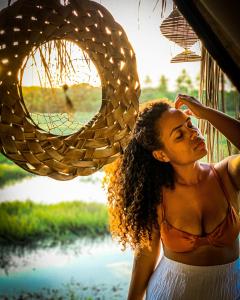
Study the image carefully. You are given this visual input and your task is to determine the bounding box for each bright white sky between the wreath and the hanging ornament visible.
[0,0,200,90]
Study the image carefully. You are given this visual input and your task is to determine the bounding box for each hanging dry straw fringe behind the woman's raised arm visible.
[199,47,240,162]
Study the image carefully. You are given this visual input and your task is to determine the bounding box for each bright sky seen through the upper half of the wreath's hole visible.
[19,41,101,88]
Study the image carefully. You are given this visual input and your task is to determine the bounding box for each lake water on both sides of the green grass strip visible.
[0,171,135,300]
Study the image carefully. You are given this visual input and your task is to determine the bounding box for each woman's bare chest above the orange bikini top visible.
[160,177,237,235]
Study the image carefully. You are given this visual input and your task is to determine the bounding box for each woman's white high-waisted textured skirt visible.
[145,256,240,300]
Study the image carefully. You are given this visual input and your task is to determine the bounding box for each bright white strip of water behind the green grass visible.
[0,171,107,204]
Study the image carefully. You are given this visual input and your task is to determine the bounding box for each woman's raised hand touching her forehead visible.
[175,94,207,119]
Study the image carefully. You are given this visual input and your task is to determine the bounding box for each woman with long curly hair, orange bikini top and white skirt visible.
[108,95,240,300]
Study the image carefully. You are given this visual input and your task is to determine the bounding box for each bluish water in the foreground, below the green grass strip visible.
[0,237,133,299]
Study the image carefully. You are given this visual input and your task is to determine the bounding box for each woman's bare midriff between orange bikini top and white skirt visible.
[163,239,239,266]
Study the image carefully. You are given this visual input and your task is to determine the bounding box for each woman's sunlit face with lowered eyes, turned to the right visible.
[156,108,207,165]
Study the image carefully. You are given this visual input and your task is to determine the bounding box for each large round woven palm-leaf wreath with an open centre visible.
[0,0,140,180]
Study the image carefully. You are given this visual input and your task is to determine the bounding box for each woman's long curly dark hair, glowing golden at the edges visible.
[106,99,174,253]
